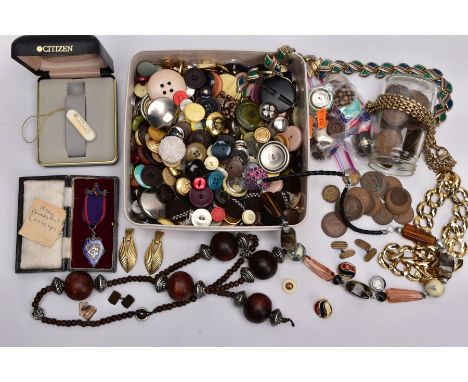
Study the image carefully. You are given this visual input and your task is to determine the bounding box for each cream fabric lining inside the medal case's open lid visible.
[20,180,70,269]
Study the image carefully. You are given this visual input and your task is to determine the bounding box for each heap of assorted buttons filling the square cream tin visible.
[129,55,303,227]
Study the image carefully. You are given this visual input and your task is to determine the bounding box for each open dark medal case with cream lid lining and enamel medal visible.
[15,176,119,273]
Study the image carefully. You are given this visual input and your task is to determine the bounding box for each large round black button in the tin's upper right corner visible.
[260,76,296,113]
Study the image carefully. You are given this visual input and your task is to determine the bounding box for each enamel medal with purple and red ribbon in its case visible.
[83,183,107,268]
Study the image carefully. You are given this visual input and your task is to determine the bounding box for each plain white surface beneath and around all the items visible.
[0,36,468,346]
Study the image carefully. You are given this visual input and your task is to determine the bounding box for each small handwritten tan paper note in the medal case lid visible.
[19,199,66,247]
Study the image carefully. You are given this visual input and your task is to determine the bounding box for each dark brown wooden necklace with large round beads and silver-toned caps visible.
[32,232,294,327]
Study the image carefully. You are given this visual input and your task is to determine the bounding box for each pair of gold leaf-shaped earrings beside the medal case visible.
[119,228,164,275]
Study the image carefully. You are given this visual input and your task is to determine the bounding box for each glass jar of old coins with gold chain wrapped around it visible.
[369,75,437,175]
